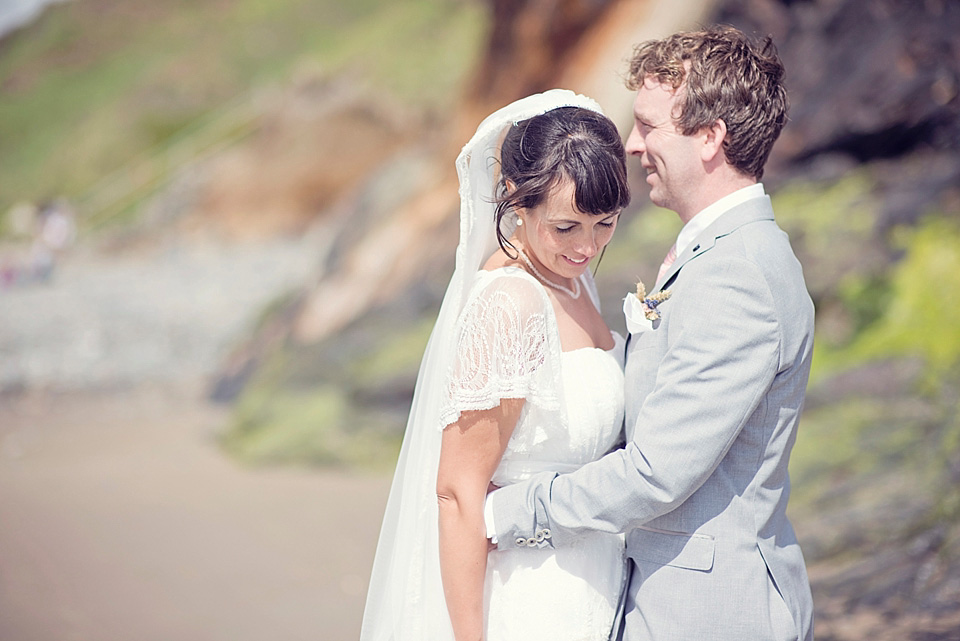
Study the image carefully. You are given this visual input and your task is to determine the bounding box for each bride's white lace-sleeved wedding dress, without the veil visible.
[441,267,625,641]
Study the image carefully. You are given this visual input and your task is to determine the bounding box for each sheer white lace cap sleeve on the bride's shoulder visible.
[440,268,560,428]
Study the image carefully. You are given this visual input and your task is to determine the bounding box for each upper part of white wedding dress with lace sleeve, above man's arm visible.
[440,267,623,485]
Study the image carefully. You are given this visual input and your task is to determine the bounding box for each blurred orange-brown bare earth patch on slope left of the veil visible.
[182,73,413,239]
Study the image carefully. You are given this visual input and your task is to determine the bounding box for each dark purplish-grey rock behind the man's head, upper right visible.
[715,0,960,229]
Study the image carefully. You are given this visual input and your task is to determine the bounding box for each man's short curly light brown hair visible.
[626,26,789,180]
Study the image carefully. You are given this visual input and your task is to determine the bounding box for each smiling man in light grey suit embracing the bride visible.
[487,27,813,641]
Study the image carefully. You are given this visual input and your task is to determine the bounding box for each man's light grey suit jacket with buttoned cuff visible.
[492,197,813,641]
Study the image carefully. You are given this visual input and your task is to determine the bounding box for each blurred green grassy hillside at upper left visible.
[0,0,485,229]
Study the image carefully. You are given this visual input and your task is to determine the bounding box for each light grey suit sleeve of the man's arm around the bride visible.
[493,252,781,548]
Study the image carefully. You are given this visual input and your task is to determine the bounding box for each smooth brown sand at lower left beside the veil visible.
[0,389,389,641]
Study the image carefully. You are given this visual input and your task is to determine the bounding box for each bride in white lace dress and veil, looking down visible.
[361,89,630,641]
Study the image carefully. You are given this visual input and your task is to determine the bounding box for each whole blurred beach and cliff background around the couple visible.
[0,0,960,641]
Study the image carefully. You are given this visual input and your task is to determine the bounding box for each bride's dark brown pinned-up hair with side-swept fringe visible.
[495,107,630,258]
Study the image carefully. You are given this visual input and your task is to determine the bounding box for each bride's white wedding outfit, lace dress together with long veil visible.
[360,89,625,641]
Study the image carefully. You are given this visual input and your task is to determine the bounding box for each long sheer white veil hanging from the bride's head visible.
[360,89,602,641]
